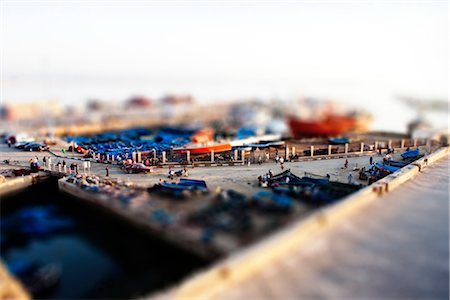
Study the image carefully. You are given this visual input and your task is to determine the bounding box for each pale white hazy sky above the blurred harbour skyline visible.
[1,1,449,130]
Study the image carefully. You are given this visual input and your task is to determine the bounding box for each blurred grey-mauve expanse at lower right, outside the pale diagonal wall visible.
[199,156,450,300]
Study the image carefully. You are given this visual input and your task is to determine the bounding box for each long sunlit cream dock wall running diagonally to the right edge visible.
[150,147,450,299]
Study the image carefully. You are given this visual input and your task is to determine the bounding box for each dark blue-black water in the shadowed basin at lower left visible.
[1,180,207,299]
